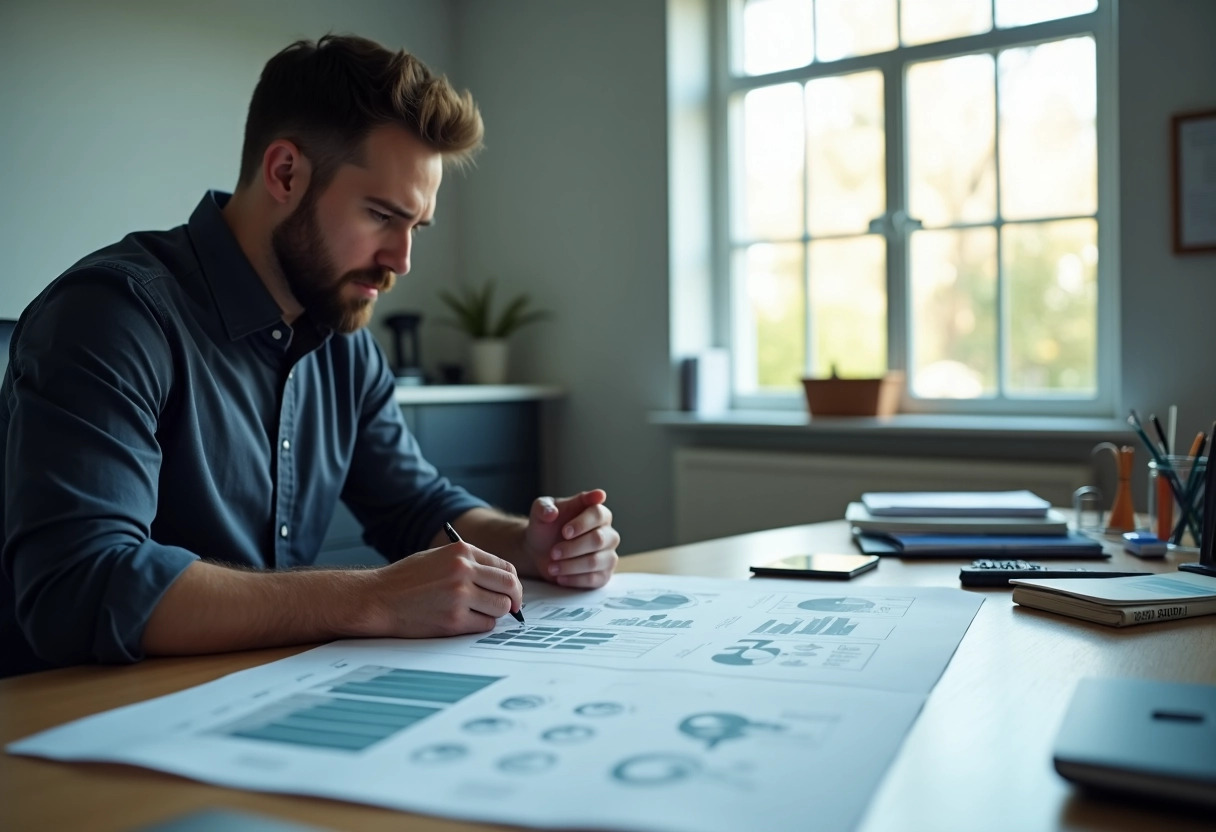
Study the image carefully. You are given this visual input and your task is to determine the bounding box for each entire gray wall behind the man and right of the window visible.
[0,0,1216,552]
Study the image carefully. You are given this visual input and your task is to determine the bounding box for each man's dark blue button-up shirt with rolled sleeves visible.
[0,192,485,675]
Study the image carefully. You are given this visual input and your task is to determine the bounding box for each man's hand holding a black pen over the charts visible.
[368,543,523,639]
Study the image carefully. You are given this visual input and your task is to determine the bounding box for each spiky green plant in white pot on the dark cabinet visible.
[439,280,550,384]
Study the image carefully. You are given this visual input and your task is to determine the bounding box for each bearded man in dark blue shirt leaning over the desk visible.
[0,36,620,674]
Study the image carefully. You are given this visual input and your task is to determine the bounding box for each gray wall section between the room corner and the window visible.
[456,0,671,551]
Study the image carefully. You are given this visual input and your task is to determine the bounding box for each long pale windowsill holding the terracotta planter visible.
[649,410,1136,442]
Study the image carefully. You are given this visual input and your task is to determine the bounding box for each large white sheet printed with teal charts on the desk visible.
[9,574,983,832]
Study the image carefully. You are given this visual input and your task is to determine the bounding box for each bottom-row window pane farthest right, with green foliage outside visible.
[1001,219,1098,395]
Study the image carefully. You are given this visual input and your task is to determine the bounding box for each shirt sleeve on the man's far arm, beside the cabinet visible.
[342,336,488,561]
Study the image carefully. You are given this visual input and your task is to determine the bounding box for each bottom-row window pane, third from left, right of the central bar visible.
[910,229,997,399]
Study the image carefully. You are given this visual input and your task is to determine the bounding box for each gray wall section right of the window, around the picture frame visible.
[1119,0,1216,450]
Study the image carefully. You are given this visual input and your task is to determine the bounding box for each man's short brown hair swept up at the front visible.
[240,35,484,187]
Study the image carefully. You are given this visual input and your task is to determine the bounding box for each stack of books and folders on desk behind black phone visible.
[845,491,1109,558]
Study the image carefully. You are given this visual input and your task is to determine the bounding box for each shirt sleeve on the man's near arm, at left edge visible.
[0,268,197,664]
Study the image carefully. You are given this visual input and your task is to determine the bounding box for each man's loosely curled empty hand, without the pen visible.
[524,488,620,589]
